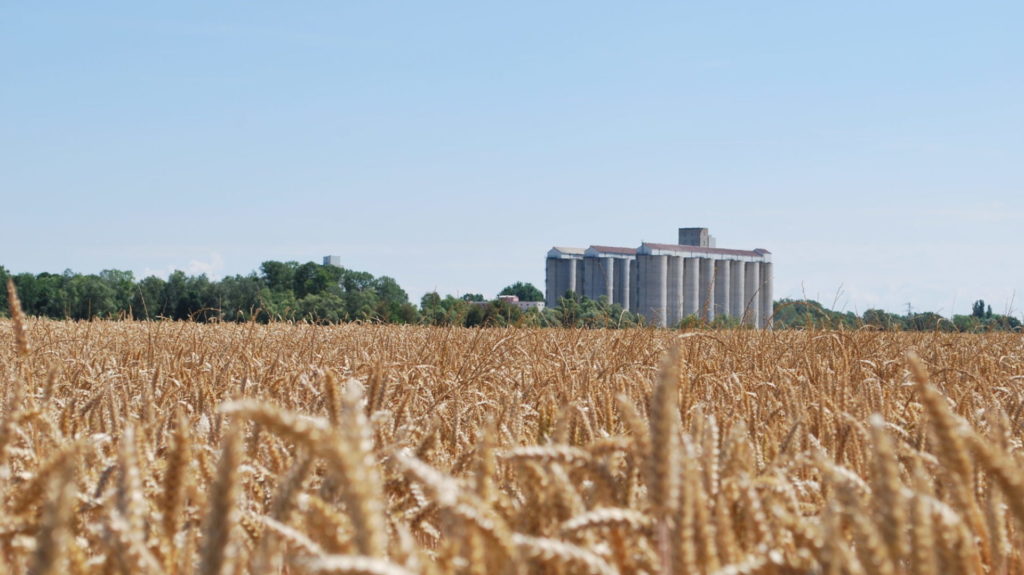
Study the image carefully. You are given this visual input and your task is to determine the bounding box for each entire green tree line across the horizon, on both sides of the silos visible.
[0,260,1021,333]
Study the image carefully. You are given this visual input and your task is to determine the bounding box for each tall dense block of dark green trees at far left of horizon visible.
[0,261,418,323]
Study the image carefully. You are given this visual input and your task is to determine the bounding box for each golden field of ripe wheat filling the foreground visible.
[0,313,1024,574]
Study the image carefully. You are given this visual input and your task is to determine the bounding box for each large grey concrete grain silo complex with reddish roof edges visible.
[545,228,773,327]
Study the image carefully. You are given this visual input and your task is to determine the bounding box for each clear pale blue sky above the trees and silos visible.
[0,0,1024,316]
